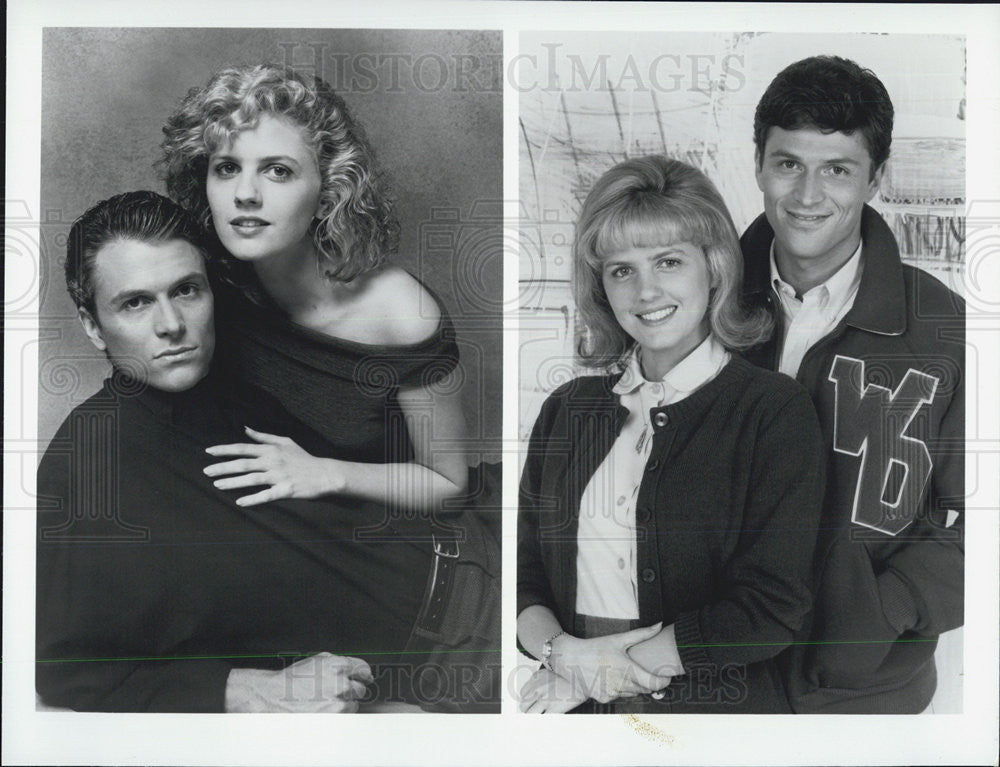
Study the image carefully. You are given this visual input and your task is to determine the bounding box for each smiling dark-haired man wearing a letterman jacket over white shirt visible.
[741,56,965,713]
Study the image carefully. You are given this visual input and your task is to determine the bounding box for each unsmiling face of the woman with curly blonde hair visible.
[205,115,322,261]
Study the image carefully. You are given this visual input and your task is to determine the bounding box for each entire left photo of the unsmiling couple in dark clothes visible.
[35,28,503,713]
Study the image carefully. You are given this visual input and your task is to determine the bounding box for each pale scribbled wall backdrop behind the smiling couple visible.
[513,32,966,713]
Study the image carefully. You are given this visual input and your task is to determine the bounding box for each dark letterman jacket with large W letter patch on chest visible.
[741,206,965,713]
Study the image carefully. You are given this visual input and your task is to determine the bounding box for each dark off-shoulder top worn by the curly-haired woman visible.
[213,285,458,463]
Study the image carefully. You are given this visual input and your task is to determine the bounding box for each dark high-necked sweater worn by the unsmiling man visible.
[36,375,431,712]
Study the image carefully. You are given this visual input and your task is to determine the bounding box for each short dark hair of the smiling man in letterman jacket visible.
[753,56,893,175]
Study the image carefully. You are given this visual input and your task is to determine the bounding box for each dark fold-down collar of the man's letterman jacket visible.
[740,205,906,336]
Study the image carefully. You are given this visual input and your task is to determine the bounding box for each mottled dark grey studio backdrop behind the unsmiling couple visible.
[38,28,503,462]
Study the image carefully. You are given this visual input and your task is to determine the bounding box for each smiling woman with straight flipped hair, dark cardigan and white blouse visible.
[517,156,822,713]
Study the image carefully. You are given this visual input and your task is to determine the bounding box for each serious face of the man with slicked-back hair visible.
[80,240,215,392]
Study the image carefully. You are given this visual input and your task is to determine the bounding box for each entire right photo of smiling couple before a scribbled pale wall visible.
[509,31,966,714]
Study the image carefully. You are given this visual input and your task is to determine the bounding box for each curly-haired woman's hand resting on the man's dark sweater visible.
[204,426,345,506]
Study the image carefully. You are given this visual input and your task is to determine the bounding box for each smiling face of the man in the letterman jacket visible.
[756,128,882,271]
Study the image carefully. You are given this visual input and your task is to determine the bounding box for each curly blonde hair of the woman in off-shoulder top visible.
[158,64,399,292]
